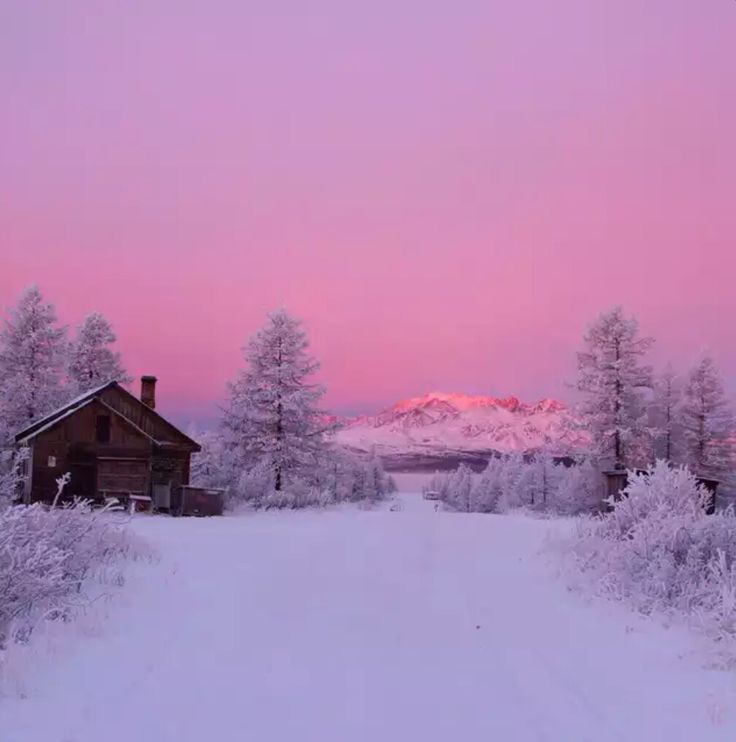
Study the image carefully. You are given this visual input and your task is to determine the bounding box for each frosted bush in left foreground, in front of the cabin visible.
[0,501,146,648]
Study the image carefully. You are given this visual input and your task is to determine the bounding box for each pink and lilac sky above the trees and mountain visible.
[0,0,736,419]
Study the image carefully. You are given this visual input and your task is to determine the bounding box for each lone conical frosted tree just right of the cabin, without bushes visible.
[222,309,325,492]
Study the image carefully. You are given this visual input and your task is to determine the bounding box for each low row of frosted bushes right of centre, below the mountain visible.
[426,455,602,515]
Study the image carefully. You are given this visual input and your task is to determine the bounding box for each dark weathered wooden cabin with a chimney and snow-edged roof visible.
[15,376,200,510]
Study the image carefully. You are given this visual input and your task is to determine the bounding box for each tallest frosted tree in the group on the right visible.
[577,307,654,467]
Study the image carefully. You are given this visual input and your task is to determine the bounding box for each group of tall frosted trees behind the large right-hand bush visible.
[577,307,734,479]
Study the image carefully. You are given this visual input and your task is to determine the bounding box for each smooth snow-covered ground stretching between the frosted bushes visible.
[0,495,736,742]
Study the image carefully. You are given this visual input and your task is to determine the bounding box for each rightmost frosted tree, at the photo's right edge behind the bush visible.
[681,356,734,477]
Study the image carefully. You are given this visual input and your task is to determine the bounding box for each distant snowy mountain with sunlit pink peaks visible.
[336,392,586,456]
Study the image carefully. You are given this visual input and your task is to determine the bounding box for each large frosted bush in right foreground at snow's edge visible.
[569,461,736,636]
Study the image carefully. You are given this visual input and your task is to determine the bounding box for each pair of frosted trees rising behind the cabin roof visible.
[0,286,129,444]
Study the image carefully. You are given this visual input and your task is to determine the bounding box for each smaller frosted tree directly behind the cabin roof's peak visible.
[68,312,132,394]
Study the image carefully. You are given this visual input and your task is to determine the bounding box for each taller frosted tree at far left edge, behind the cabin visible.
[0,286,67,439]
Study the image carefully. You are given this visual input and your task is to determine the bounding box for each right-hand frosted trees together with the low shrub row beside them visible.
[429,307,736,514]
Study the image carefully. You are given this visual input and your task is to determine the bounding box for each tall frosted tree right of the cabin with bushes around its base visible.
[192,309,393,507]
